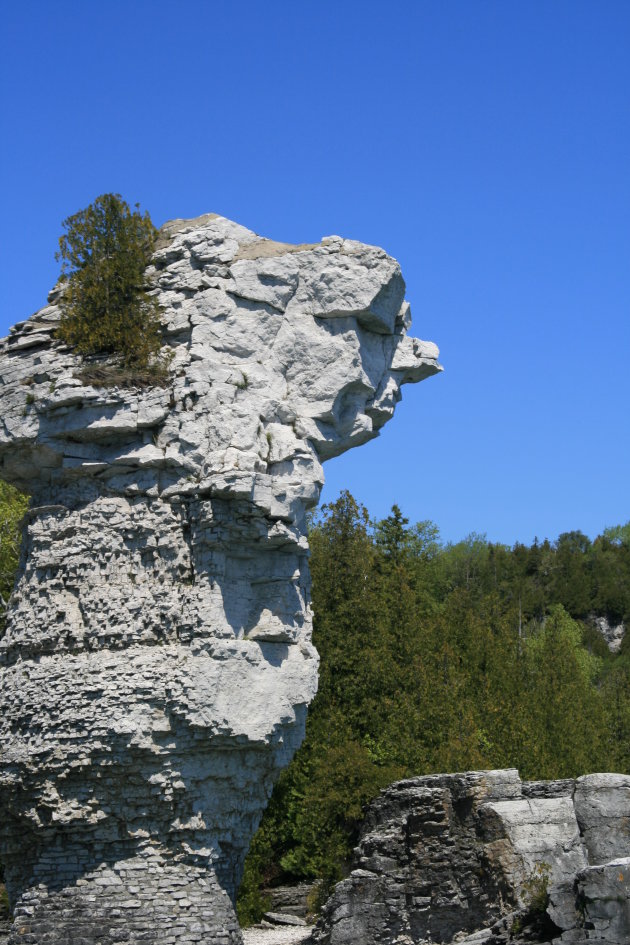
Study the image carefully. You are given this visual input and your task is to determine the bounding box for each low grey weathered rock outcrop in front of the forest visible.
[314,769,630,945]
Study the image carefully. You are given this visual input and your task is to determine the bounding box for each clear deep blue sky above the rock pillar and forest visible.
[0,0,630,544]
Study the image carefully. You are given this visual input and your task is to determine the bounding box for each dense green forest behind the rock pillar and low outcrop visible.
[240,492,630,921]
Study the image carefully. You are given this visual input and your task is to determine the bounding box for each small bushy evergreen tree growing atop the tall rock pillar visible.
[57,194,161,373]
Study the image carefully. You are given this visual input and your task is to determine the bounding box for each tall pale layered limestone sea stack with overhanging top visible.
[0,214,440,945]
